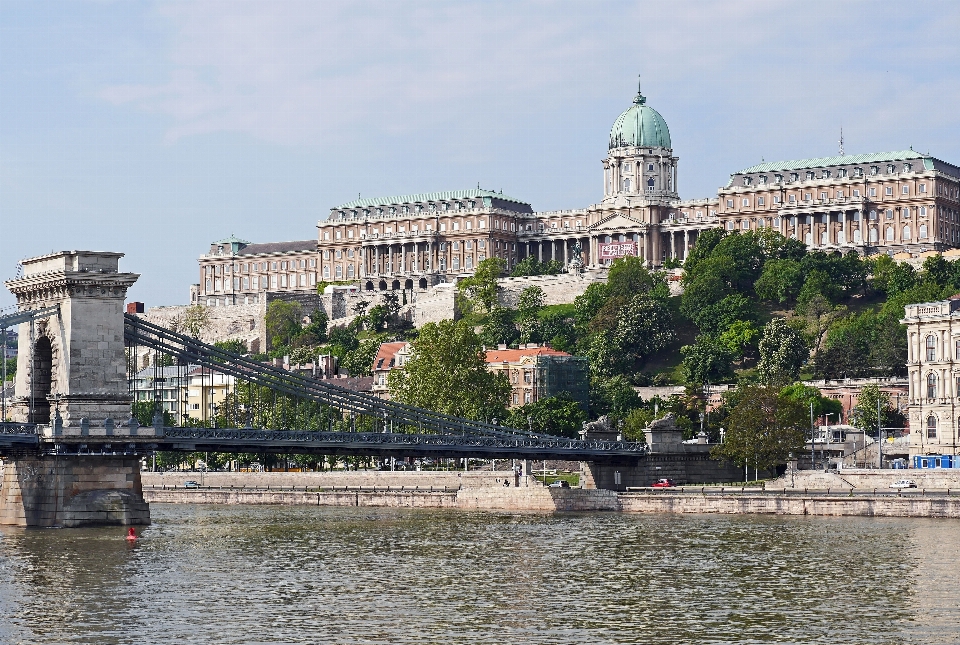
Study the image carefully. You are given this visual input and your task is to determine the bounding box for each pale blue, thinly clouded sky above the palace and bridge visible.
[0,0,960,308]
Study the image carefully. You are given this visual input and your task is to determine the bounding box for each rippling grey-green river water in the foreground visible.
[0,504,960,645]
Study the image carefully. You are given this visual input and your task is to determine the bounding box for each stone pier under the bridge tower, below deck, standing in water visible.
[0,455,150,527]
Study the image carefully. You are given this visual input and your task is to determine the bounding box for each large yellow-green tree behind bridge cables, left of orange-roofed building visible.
[388,320,510,419]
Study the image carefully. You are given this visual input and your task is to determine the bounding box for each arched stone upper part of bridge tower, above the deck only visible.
[6,251,140,428]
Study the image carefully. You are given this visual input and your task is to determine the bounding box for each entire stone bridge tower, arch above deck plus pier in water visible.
[0,251,150,526]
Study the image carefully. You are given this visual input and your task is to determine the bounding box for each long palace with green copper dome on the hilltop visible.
[191,83,960,305]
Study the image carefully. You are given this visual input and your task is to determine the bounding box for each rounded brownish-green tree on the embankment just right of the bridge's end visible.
[711,386,809,470]
